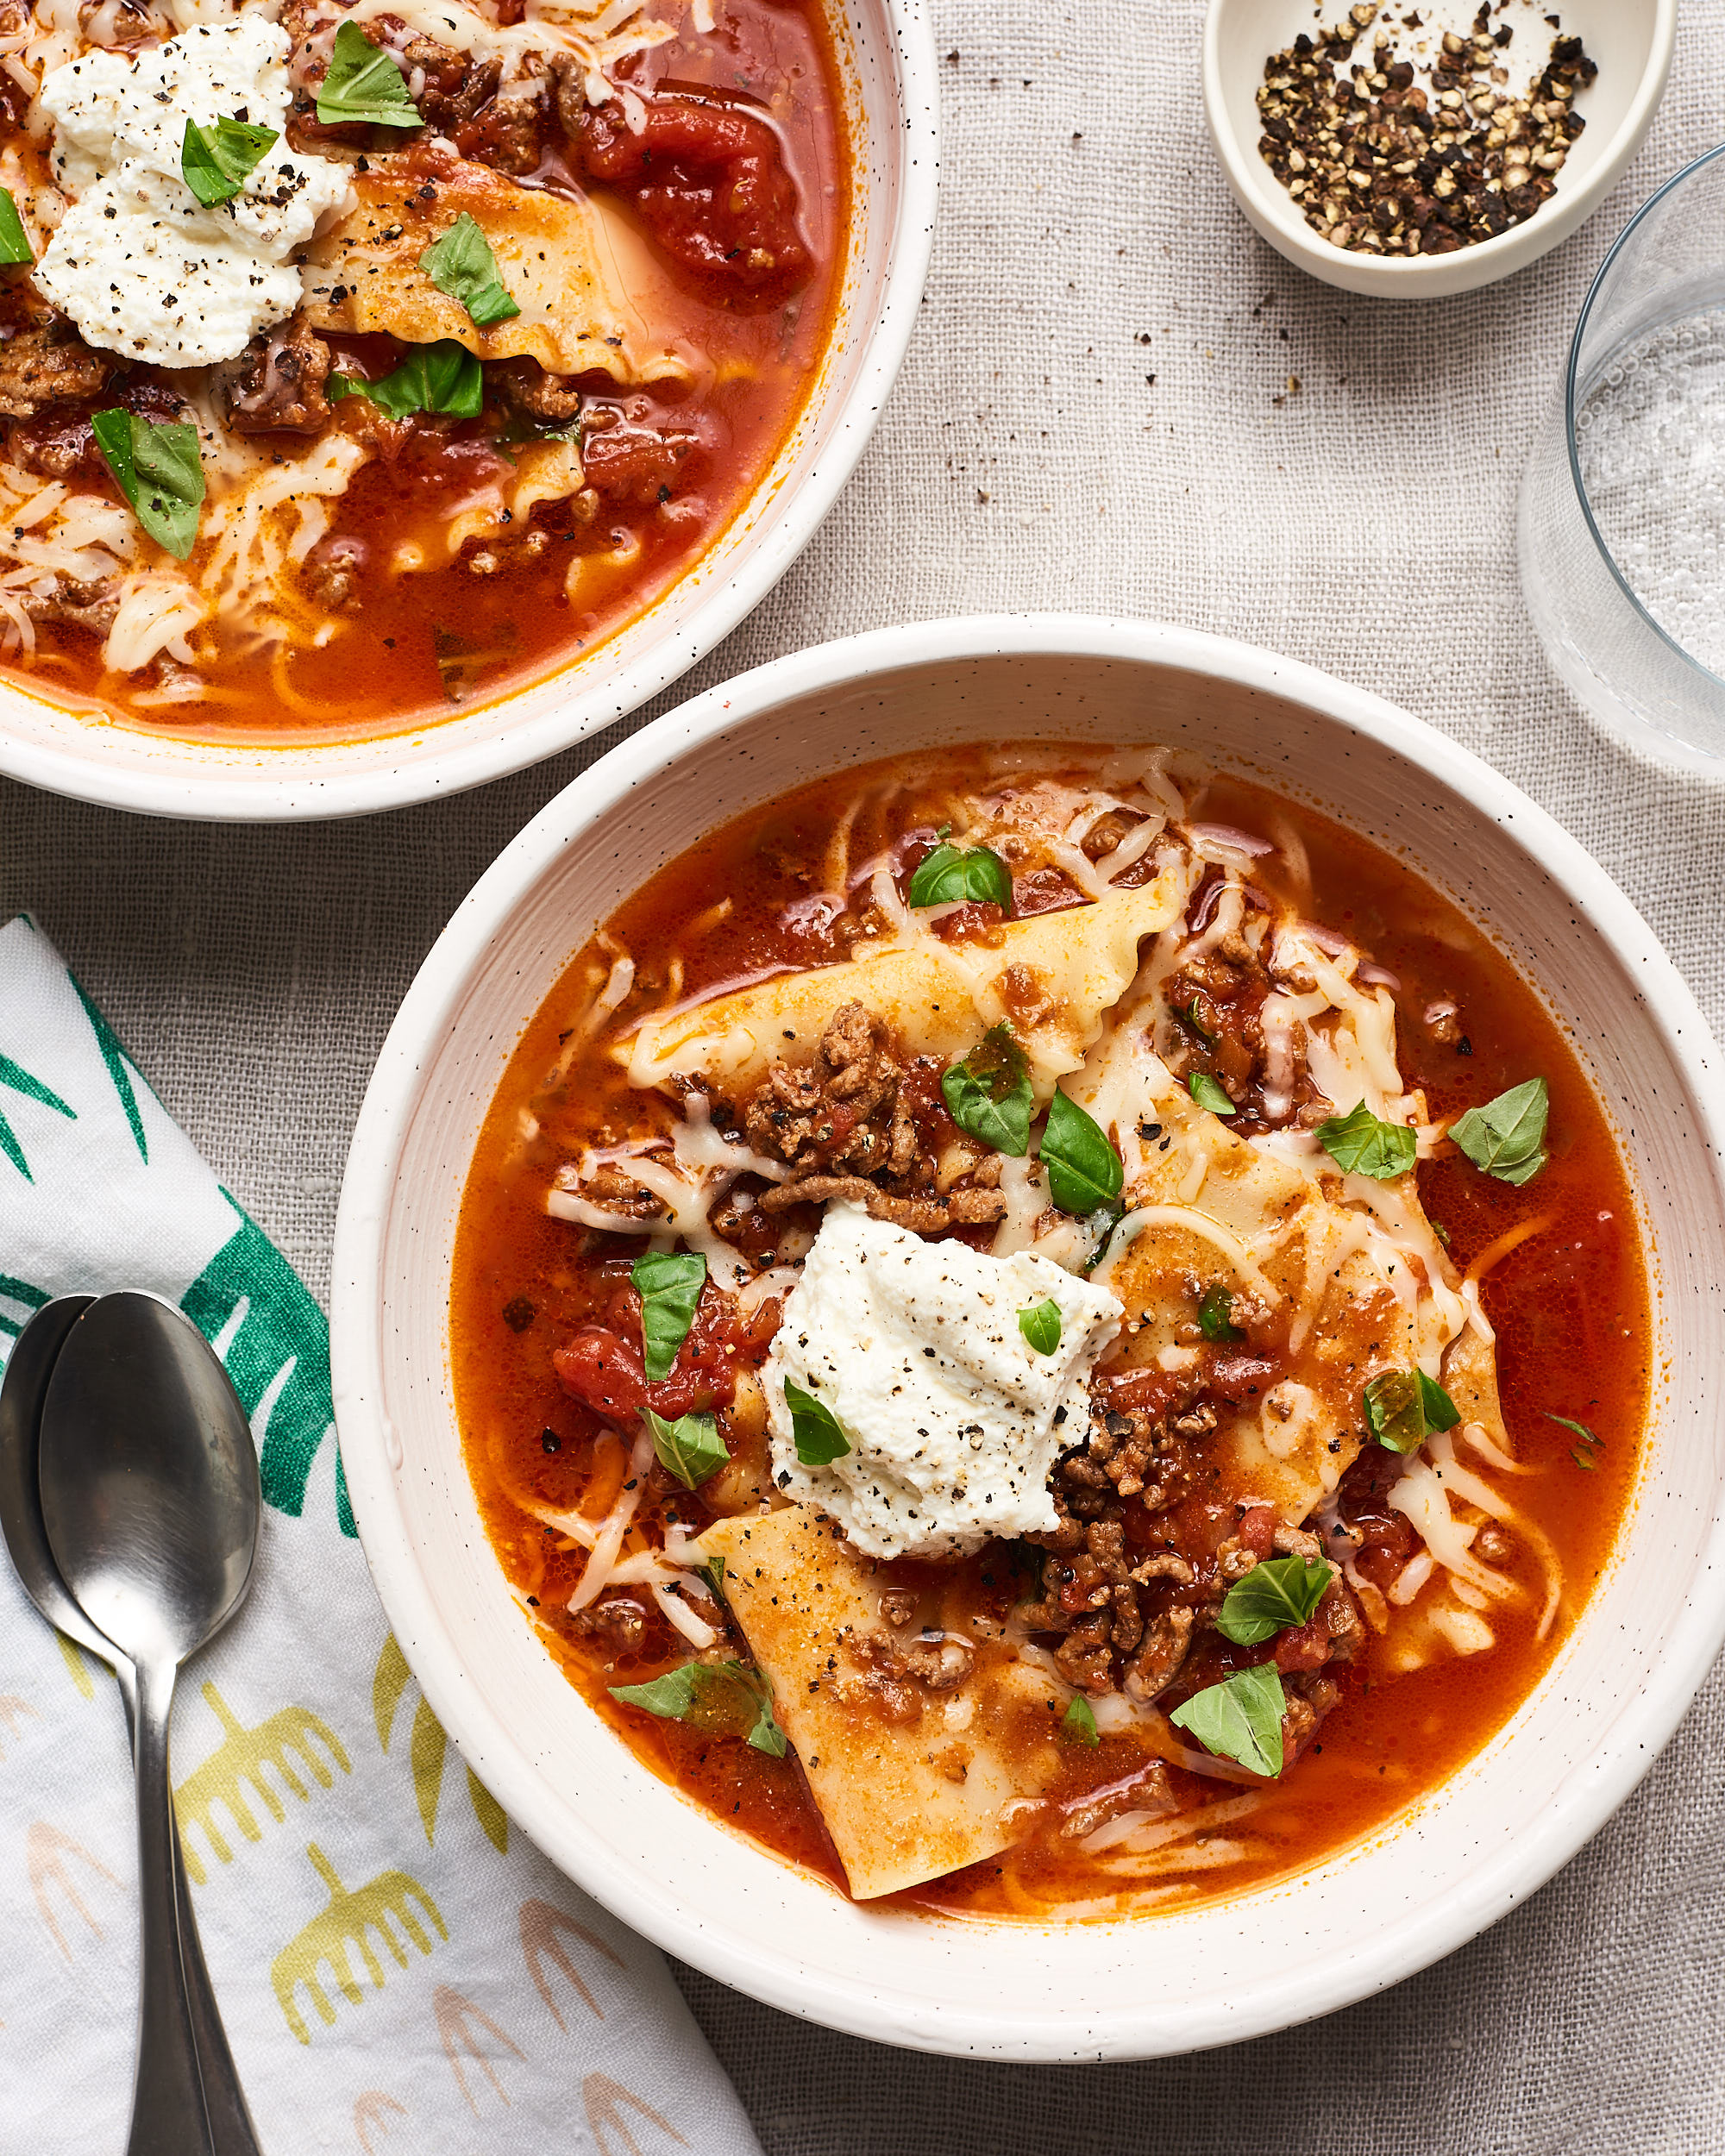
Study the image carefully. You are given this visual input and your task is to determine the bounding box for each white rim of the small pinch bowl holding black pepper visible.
[1203,0,1678,300]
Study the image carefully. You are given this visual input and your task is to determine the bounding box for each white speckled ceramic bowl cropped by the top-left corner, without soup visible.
[0,0,936,819]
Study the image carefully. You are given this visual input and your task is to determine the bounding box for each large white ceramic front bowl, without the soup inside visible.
[332,615,1725,2059]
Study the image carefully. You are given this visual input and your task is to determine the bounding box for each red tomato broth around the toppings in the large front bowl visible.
[451,749,1652,1915]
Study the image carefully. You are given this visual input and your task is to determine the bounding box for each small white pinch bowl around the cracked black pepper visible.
[1203,0,1678,300]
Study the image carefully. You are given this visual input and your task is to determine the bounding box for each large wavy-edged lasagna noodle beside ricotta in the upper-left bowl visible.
[304,151,699,384]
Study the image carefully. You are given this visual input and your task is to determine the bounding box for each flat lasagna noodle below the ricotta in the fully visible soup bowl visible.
[701,1505,1068,1902]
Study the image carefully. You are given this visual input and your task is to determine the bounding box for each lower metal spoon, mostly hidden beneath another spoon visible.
[0,1296,259,2156]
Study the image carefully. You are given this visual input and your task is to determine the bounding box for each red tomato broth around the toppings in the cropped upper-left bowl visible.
[0,0,850,744]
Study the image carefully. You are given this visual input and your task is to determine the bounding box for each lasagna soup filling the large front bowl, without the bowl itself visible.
[453,746,1650,1917]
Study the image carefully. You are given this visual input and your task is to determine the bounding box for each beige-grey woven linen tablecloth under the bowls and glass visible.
[0,0,1725,2156]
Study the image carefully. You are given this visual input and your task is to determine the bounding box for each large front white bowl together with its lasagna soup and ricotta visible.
[332,617,1725,2059]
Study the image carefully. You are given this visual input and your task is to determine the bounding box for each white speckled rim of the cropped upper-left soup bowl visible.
[0,0,940,824]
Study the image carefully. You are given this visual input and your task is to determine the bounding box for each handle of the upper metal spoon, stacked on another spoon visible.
[125,1660,214,2156]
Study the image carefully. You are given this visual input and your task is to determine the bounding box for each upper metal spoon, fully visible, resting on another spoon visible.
[37,1292,261,2156]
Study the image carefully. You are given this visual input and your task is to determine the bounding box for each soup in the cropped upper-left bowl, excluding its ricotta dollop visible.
[0,0,850,742]
